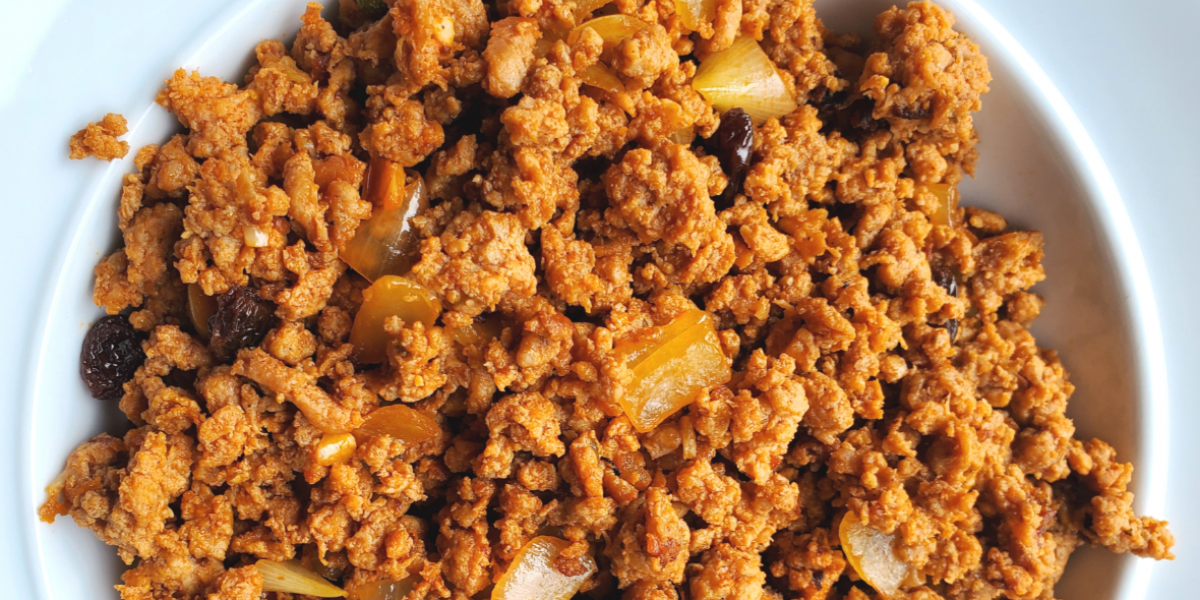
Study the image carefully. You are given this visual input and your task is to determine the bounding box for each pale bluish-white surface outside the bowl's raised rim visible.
[0,0,1200,599]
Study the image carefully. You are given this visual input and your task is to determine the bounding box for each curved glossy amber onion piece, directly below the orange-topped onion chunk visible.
[350,275,442,365]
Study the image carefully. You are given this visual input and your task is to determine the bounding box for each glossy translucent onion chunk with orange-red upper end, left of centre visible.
[340,158,430,281]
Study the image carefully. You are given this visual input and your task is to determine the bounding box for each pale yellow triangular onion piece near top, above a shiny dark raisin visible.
[691,36,796,125]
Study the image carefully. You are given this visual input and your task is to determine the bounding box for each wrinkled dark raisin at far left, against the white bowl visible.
[79,314,146,400]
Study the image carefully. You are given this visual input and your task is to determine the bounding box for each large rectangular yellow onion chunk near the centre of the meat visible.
[614,308,730,432]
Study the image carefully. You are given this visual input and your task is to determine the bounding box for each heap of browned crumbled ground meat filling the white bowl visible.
[41,0,1174,600]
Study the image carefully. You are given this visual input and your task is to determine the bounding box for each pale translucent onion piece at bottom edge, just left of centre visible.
[492,535,596,600]
